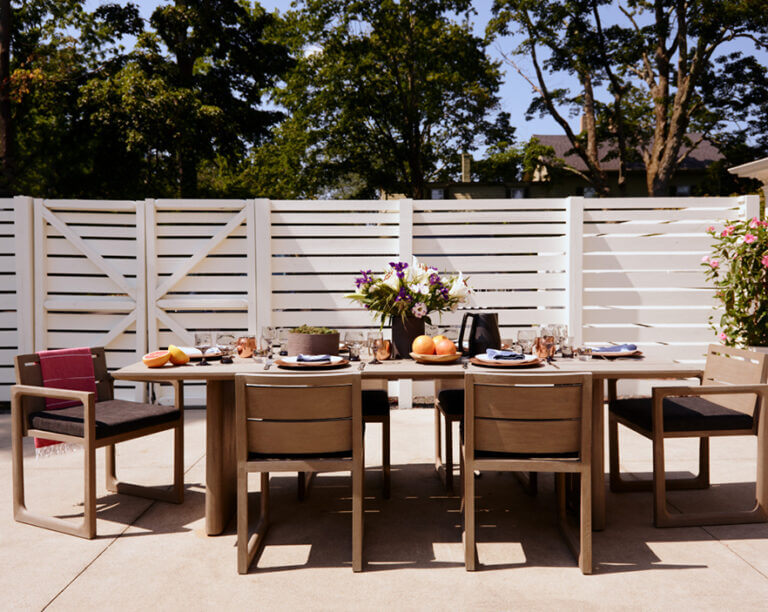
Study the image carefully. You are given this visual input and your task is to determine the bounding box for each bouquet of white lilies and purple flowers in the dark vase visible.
[345,258,472,325]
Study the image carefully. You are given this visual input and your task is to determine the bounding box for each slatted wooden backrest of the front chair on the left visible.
[236,374,361,456]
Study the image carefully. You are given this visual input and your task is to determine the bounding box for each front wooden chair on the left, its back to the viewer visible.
[235,373,365,574]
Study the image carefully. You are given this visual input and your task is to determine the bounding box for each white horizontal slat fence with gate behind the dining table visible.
[0,196,758,404]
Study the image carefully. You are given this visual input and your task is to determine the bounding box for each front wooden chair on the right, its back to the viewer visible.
[462,373,592,574]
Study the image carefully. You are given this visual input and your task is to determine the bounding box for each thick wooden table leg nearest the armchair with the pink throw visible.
[205,380,237,535]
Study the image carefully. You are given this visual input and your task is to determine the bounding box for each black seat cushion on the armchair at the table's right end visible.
[609,397,752,432]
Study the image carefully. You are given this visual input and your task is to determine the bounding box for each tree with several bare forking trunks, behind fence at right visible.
[488,0,768,196]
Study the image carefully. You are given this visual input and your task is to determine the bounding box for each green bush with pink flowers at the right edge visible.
[701,217,768,346]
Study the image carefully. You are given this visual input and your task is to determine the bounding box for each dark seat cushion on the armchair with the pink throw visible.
[29,400,179,439]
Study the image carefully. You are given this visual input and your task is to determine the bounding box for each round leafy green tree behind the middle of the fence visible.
[263,0,500,198]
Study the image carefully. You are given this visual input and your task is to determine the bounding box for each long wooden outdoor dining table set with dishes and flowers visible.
[112,358,701,535]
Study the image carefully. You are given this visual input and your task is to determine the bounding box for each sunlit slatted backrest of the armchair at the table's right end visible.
[701,344,768,415]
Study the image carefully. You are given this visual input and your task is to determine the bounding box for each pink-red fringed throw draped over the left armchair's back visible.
[35,346,96,449]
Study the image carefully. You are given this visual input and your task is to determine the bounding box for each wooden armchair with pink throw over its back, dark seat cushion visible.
[11,347,184,539]
